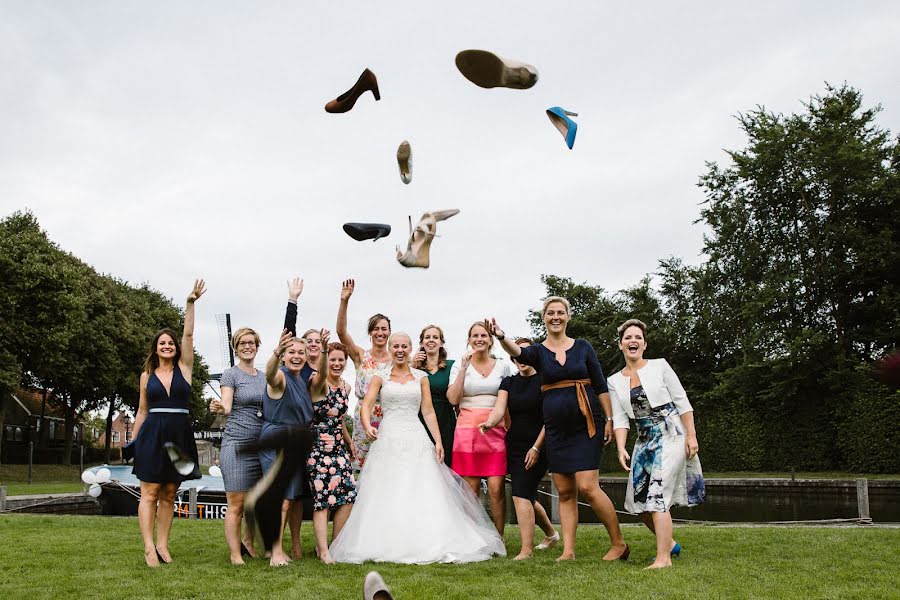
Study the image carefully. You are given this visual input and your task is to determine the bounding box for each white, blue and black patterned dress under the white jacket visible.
[625,385,706,513]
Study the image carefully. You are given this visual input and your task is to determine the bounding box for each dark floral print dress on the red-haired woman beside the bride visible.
[306,384,356,510]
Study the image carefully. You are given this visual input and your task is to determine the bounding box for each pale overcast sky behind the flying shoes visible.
[0,0,900,394]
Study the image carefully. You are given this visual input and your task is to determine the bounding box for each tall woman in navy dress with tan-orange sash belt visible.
[490,296,629,560]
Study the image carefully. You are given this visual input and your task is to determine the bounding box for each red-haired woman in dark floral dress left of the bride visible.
[306,329,356,564]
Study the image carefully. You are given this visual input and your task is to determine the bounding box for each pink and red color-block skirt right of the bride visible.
[451,408,506,477]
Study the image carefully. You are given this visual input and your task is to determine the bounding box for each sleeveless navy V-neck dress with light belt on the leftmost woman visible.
[133,365,200,483]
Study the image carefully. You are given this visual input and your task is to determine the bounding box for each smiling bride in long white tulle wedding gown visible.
[330,332,506,564]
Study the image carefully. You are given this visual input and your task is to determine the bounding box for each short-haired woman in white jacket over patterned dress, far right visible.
[608,319,706,569]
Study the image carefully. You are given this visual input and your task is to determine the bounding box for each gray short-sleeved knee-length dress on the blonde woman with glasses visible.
[219,367,266,492]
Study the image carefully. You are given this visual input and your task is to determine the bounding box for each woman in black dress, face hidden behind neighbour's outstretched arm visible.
[479,338,559,560]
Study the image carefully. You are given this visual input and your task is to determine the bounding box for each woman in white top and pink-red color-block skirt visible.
[447,321,516,536]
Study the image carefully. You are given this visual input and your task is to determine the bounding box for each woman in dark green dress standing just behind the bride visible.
[413,325,456,467]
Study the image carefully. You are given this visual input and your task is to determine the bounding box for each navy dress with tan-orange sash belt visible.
[516,339,608,473]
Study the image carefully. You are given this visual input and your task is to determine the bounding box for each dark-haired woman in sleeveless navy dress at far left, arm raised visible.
[134,279,206,567]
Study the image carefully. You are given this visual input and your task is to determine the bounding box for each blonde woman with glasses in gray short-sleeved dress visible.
[209,327,266,565]
